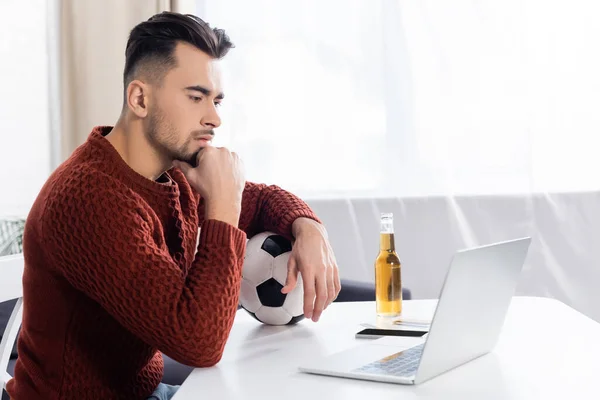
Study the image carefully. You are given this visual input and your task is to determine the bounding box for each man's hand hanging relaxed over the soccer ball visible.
[281,218,341,322]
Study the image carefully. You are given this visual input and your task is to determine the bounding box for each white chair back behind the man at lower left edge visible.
[0,254,25,396]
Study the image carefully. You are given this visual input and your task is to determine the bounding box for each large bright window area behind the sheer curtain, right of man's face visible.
[197,0,600,197]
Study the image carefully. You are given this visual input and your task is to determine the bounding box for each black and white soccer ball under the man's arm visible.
[240,232,304,325]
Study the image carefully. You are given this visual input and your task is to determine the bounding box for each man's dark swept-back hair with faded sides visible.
[123,11,234,90]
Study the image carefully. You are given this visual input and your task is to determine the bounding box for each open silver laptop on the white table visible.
[299,237,531,385]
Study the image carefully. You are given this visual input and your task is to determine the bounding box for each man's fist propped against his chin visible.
[173,146,246,227]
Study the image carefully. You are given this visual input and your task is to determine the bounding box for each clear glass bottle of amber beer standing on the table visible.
[375,213,402,317]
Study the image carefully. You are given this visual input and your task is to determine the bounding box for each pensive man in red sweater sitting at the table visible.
[7,13,340,400]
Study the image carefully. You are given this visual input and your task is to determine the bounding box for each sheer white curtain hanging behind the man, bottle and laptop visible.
[196,0,600,320]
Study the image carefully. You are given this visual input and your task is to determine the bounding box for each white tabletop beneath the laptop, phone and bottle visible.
[174,297,600,400]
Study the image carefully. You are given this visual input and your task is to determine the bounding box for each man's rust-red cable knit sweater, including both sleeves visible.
[7,127,318,400]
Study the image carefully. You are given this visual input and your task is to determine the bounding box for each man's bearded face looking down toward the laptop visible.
[144,43,223,165]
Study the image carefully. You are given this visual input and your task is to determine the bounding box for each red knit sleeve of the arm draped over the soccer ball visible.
[198,182,321,239]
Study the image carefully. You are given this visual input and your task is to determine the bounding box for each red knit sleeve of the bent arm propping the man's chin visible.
[42,180,246,367]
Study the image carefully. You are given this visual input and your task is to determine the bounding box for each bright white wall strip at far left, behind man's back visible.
[0,0,51,218]
